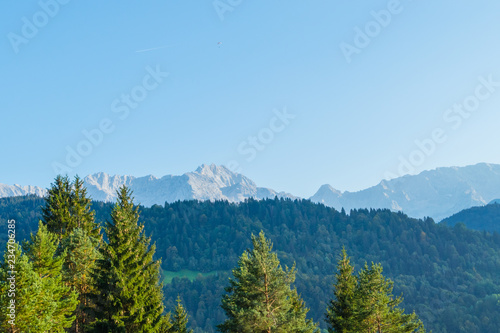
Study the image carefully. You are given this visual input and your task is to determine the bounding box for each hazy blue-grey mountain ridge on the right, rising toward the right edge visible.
[310,163,500,221]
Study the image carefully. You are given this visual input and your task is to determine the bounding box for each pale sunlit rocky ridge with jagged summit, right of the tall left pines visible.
[84,164,295,206]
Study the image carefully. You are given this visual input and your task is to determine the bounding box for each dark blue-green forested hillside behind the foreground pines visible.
[0,197,500,333]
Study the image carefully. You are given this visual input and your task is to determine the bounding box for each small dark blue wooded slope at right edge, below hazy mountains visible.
[442,203,500,232]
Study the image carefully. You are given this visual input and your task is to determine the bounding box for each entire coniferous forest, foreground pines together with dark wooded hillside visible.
[0,177,500,333]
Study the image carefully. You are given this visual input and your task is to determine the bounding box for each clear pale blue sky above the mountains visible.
[0,0,500,197]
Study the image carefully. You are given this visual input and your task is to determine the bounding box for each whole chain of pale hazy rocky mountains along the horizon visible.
[0,163,500,221]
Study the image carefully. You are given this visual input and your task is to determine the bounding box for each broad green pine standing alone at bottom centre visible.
[218,231,317,333]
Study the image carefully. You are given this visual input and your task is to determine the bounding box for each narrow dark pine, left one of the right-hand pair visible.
[326,248,358,333]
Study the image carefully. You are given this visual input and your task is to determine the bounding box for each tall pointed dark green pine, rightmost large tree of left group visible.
[93,186,163,333]
